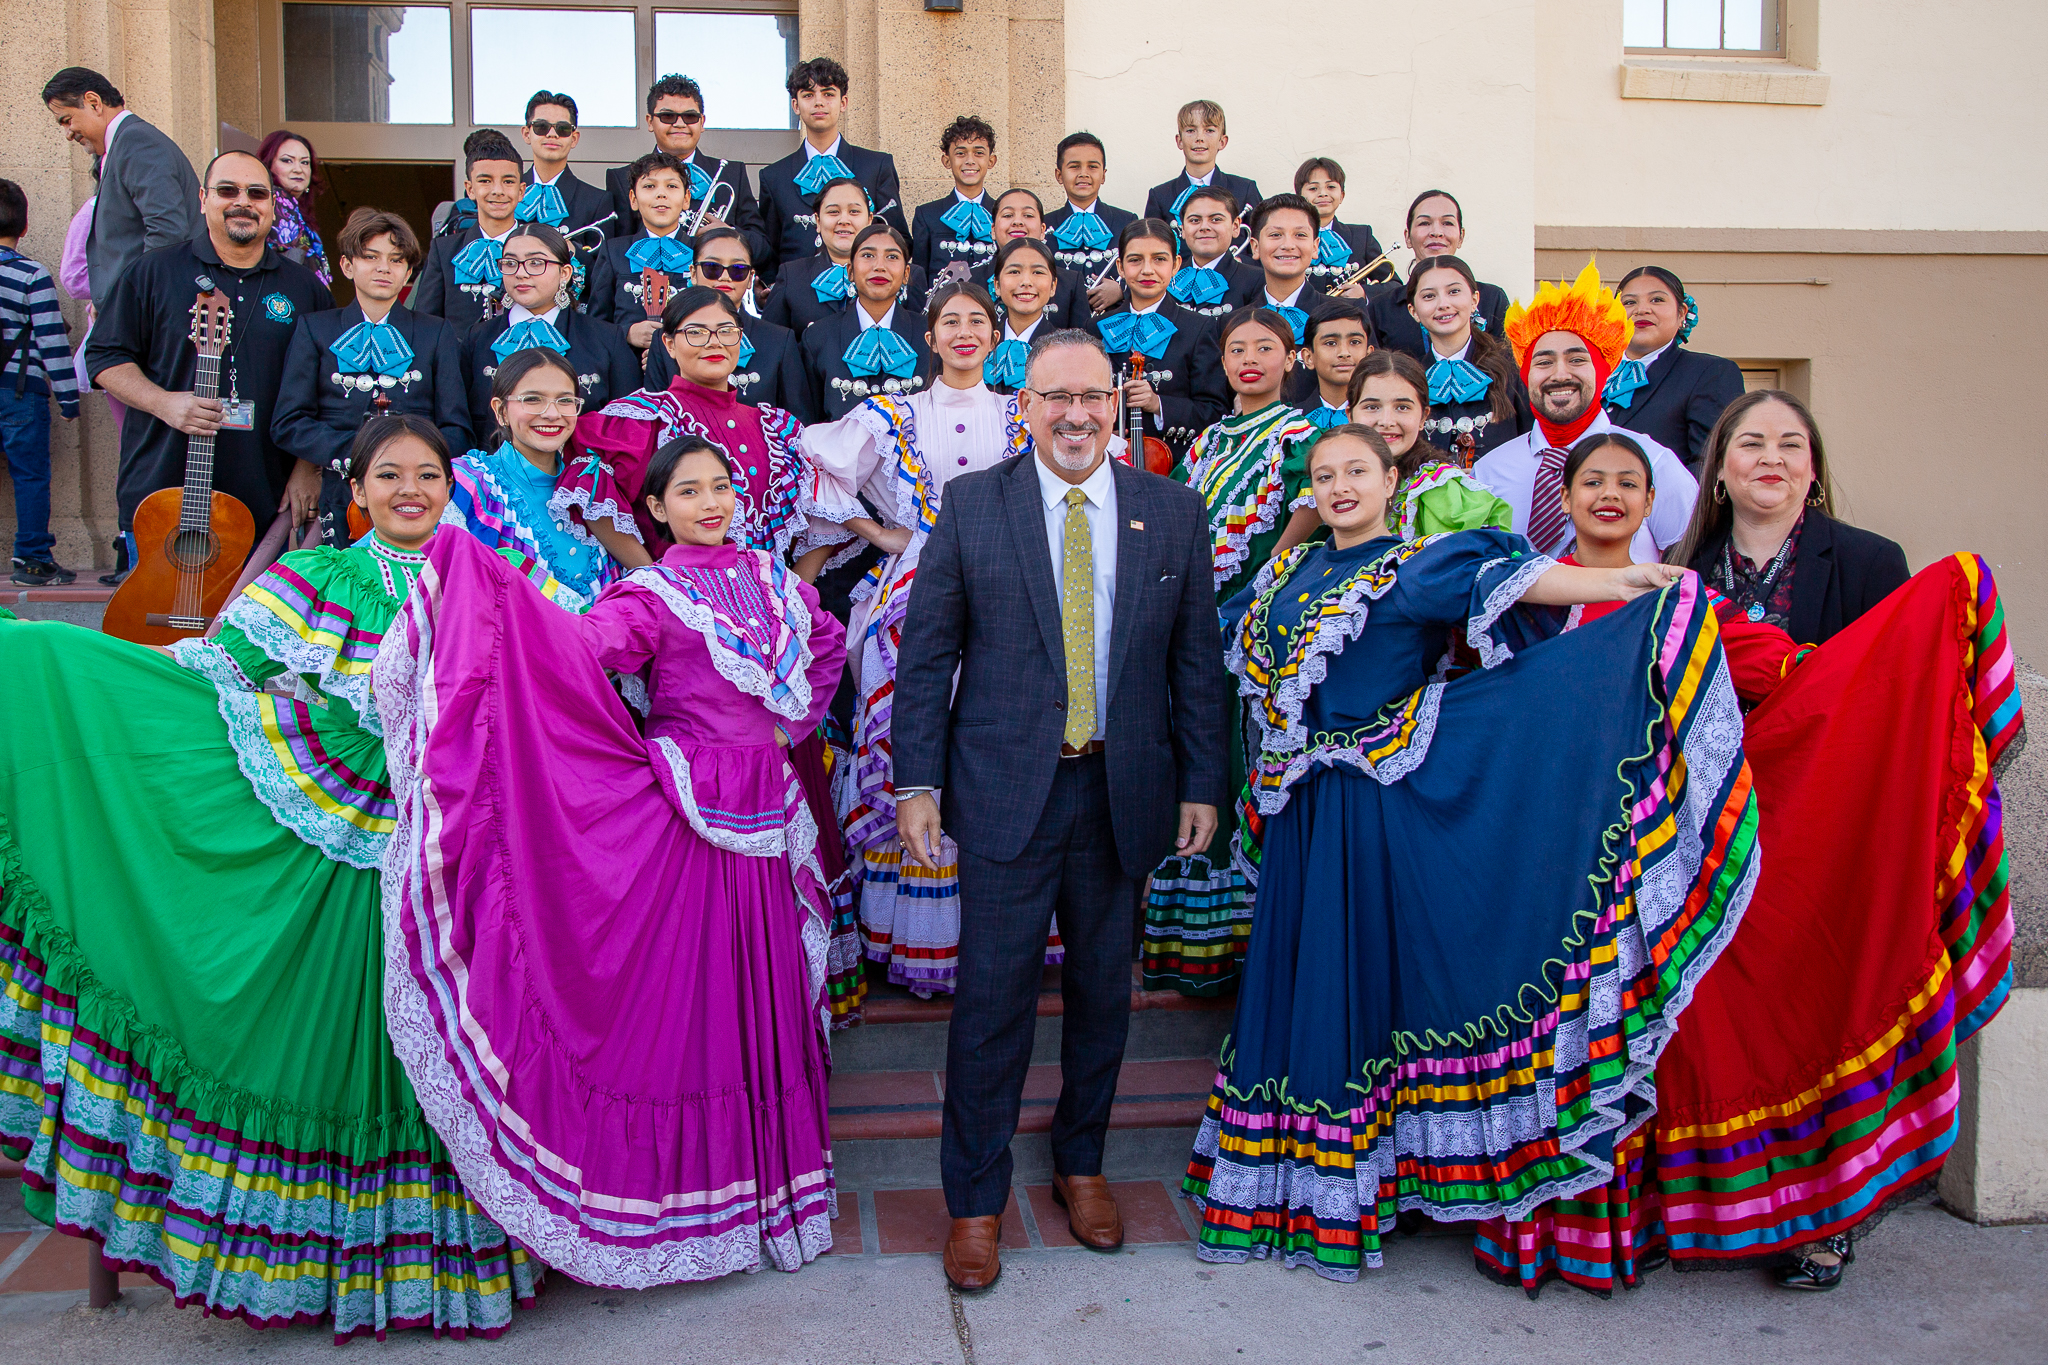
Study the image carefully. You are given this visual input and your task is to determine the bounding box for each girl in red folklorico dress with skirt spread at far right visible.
[1475,421,2023,1297]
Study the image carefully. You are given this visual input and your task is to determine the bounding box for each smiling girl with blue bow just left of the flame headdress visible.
[1407,256,1536,469]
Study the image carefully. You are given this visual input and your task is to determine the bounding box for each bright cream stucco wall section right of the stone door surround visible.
[1067,0,1536,295]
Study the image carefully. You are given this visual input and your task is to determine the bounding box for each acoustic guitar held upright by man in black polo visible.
[102,276,256,645]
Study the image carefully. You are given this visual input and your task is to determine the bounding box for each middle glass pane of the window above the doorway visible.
[469,10,641,127]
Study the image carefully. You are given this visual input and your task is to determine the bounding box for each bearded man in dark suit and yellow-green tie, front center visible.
[893,329,1229,1289]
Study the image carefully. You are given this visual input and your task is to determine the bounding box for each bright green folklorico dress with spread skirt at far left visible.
[0,538,551,1338]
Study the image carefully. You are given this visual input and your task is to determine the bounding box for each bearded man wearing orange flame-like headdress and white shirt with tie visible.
[1473,260,1700,561]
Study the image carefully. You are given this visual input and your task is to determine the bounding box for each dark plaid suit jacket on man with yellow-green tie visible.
[893,456,1229,880]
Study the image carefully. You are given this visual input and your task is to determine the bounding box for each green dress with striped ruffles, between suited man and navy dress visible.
[1145,403,1321,995]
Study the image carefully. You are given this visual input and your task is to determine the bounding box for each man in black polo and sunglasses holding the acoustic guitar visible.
[86,151,334,565]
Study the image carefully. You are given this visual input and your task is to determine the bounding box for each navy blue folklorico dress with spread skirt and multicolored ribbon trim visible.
[1184,530,1759,1279]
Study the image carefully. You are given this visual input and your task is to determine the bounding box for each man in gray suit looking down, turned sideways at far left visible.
[43,65,205,313]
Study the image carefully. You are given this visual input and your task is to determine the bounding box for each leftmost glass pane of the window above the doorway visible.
[285,4,455,123]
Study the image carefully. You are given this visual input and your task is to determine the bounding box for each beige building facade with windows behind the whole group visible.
[0,0,2048,1222]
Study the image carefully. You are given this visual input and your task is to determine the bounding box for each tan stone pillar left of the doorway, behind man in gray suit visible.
[0,0,217,569]
